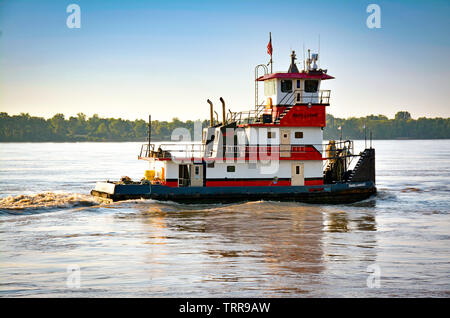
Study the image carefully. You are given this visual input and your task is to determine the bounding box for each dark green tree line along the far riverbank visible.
[0,111,450,142]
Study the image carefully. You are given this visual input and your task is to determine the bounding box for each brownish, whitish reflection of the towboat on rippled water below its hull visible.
[128,202,376,296]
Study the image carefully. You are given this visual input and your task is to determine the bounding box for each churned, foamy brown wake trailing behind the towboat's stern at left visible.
[0,192,99,210]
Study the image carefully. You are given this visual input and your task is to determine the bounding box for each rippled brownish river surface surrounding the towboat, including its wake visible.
[0,140,450,297]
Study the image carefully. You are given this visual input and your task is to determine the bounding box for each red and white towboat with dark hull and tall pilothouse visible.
[91,42,376,204]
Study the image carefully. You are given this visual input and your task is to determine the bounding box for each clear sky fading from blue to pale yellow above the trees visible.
[0,0,450,120]
